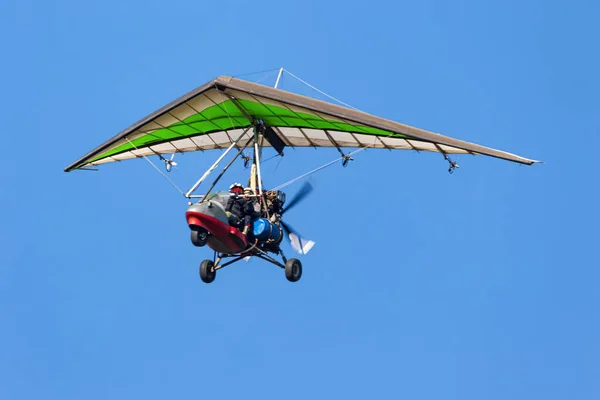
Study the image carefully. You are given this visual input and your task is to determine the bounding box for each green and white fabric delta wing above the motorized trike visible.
[65,77,537,172]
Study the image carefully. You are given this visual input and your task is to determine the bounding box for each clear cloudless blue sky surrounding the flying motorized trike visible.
[0,0,600,400]
